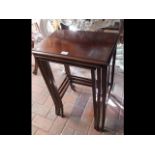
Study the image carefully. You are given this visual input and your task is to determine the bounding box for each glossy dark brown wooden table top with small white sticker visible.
[33,30,118,64]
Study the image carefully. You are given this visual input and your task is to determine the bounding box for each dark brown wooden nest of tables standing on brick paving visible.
[33,30,118,131]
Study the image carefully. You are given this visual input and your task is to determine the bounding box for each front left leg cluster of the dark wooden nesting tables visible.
[37,58,63,117]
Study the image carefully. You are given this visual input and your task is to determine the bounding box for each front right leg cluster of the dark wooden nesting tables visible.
[91,67,107,131]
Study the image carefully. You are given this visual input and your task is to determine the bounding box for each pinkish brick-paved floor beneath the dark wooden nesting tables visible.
[32,57,124,135]
